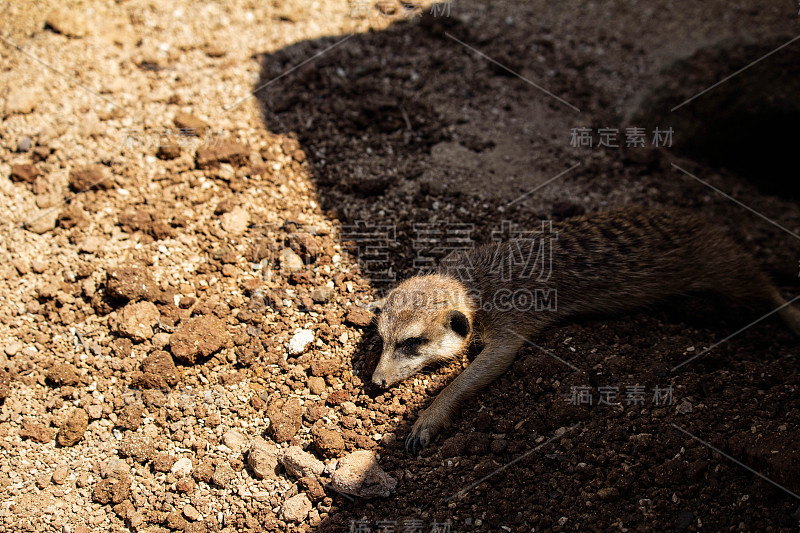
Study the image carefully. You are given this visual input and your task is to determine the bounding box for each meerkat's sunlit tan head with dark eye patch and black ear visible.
[371,274,472,387]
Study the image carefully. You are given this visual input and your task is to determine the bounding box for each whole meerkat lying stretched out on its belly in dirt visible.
[370,208,800,453]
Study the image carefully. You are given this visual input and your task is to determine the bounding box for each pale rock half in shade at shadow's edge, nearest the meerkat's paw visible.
[331,450,397,498]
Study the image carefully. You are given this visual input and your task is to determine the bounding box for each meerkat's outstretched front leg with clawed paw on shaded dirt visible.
[406,333,526,453]
